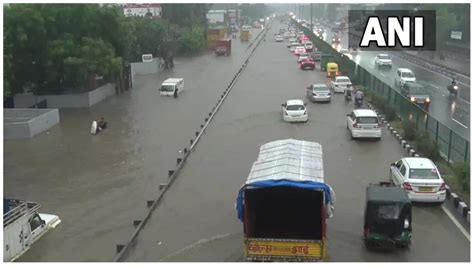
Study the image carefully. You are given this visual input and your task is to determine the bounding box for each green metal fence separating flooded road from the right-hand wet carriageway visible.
[293,20,470,163]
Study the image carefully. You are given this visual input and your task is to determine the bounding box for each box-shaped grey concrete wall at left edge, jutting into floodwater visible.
[3,108,59,139]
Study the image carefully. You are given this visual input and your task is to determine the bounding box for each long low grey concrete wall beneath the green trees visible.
[13,83,115,108]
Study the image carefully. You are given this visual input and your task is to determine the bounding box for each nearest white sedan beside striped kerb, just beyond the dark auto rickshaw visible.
[390,157,446,203]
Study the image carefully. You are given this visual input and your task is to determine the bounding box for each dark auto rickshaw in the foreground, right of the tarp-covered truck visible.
[364,182,412,249]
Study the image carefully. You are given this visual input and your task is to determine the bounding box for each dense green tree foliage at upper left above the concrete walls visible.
[4,4,208,97]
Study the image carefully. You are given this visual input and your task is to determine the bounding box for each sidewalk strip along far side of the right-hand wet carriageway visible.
[403,51,471,76]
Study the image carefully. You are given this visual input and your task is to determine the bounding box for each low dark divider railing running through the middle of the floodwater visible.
[113,18,273,262]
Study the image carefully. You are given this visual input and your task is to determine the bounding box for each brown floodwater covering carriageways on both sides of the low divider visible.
[4,20,470,262]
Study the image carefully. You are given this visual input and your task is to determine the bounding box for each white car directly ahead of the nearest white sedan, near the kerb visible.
[347,109,382,140]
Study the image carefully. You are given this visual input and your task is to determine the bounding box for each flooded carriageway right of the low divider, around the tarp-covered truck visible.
[123,23,470,262]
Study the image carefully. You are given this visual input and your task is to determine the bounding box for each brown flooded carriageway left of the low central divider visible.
[4,30,260,261]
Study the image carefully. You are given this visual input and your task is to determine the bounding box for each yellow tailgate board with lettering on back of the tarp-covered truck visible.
[245,239,323,258]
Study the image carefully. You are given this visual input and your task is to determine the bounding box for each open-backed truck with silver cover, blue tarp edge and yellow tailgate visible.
[236,139,335,261]
